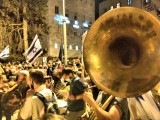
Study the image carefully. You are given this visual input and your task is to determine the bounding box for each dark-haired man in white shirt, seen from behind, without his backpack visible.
[18,70,52,120]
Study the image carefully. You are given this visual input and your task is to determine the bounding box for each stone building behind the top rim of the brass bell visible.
[98,0,160,19]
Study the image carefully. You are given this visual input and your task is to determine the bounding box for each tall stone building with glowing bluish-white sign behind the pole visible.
[47,0,95,57]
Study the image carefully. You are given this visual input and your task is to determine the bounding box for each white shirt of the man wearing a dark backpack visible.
[20,85,52,120]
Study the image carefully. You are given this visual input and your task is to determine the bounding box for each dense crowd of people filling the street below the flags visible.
[0,59,160,120]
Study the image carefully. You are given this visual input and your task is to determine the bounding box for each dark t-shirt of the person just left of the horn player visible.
[67,77,87,112]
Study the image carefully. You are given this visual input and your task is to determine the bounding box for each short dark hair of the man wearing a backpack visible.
[29,69,45,85]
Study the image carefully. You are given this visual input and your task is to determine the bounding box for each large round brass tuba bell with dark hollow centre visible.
[83,7,160,98]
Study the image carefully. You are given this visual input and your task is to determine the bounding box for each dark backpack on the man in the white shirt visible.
[34,92,60,114]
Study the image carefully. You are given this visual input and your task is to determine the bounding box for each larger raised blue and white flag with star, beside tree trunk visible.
[24,35,43,64]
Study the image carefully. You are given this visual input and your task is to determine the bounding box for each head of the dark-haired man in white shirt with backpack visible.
[29,69,45,87]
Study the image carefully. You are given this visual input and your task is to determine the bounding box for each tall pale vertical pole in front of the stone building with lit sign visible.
[63,0,67,65]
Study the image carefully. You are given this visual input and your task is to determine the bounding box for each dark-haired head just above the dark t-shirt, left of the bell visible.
[62,68,74,80]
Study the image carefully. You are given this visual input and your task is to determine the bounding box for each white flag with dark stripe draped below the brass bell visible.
[127,91,160,120]
